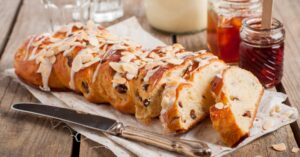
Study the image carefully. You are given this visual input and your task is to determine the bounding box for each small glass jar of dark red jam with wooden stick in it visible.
[240,18,285,88]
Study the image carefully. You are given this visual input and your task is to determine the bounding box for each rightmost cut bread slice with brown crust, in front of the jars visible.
[210,67,264,147]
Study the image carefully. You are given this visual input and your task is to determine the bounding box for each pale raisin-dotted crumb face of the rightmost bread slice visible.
[223,67,263,132]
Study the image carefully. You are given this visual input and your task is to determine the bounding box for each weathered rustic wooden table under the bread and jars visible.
[0,0,300,157]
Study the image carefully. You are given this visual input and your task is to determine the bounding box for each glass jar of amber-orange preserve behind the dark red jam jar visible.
[207,0,262,63]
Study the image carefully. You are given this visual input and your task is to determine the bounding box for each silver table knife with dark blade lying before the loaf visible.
[11,103,211,156]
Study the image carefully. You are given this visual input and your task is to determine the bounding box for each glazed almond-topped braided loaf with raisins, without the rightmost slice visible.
[14,22,261,147]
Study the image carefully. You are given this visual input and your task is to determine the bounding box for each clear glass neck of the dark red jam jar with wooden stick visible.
[240,18,285,46]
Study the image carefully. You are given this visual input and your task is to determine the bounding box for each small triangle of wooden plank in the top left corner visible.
[0,0,21,55]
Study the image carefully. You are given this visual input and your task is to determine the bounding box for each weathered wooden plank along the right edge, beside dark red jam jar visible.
[274,0,300,129]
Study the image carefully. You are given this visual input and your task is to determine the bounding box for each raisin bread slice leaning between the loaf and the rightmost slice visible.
[160,58,227,132]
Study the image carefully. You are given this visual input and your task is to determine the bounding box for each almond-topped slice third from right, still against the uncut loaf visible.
[133,45,215,123]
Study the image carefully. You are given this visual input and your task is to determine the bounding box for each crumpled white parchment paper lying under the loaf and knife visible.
[5,17,298,157]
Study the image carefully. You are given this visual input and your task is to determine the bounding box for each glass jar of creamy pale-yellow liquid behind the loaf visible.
[144,0,207,33]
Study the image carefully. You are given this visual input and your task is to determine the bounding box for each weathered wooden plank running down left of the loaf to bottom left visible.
[0,0,73,156]
